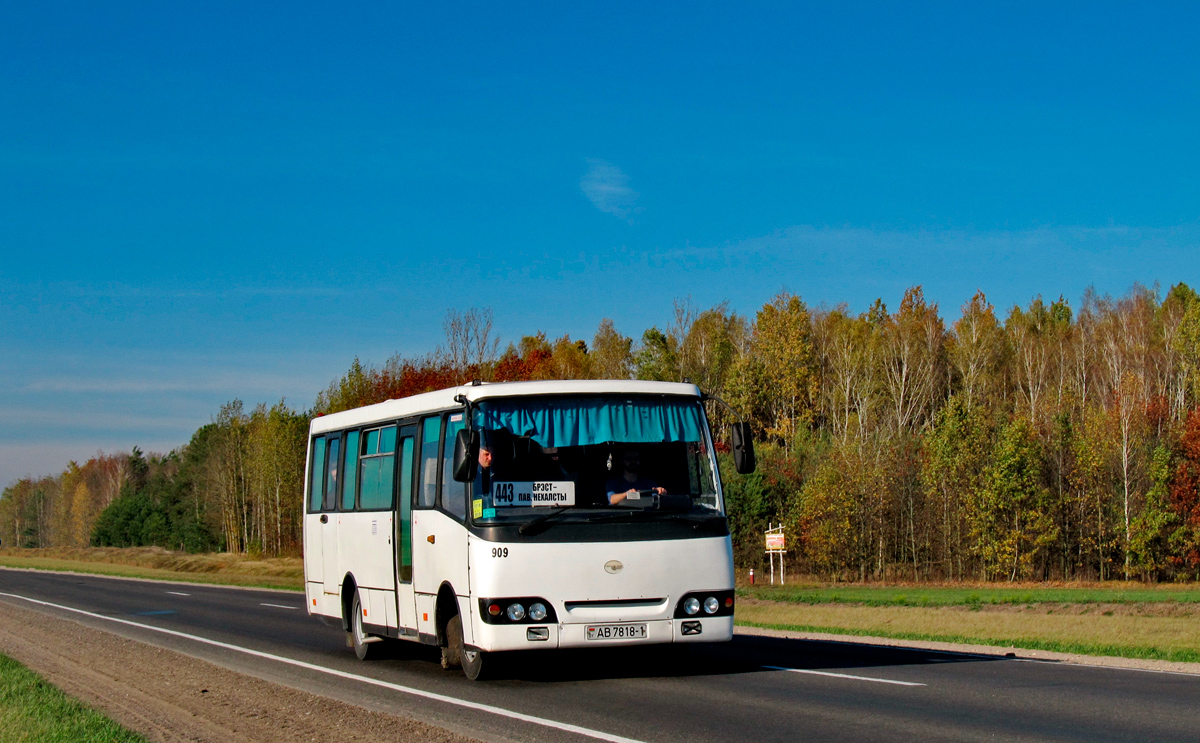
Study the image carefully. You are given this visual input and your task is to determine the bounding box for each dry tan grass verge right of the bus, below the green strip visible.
[737,599,1200,663]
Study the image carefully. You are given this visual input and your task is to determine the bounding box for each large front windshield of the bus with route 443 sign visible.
[470,395,724,525]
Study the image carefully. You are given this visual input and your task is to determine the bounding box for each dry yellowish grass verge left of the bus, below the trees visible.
[0,547,304,591]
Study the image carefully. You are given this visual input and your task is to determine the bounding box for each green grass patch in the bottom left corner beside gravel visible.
[0,655,145,743]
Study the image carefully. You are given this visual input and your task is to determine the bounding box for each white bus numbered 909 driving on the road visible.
[304,381,754,679]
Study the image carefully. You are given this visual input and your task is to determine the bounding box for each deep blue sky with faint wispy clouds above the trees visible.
[0,2,1200,485]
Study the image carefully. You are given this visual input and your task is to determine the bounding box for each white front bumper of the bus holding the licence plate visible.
[470,617,733,652]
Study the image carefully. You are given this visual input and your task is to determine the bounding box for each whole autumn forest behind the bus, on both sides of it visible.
[0,283,1200,580]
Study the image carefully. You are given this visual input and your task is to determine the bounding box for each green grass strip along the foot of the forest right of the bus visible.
[738,582,1200,606]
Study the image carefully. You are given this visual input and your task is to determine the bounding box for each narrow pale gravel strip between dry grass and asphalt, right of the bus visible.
[733,624,1200,676]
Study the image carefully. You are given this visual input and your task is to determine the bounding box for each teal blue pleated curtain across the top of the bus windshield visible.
[475,397,703,447]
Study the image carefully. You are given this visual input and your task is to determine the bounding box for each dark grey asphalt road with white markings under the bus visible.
[0,570,1200,743]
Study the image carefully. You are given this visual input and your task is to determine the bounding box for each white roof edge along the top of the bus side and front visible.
[308,379,701,433]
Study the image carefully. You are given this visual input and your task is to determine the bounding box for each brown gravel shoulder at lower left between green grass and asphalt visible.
[0,601,474,743]
